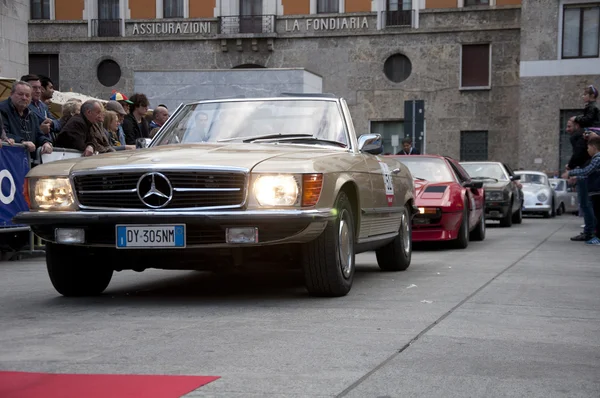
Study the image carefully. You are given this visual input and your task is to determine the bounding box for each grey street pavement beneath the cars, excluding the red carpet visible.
[0,215,600,398]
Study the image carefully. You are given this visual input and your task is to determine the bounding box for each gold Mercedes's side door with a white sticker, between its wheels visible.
[364,154,412,236]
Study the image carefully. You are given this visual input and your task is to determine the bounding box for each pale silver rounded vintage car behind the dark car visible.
[515,170,559,218]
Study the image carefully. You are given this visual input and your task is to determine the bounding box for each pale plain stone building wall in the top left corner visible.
[0,0,29,78]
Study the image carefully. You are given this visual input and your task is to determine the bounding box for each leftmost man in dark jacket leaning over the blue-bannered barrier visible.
[0,81,52,153]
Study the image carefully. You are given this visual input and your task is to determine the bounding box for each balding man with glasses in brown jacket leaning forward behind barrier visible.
[56,100,115,156]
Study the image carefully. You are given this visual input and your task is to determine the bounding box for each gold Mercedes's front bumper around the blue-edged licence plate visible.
[13,209,336,248]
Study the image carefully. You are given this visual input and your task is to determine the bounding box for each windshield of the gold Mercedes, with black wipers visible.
[153,100,348,147]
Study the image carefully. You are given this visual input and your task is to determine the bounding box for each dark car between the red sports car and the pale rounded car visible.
[460,162,523,227]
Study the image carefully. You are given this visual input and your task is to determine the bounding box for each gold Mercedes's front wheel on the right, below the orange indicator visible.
[302,191,356,297]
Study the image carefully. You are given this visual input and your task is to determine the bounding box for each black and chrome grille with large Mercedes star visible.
[73,171,247,210]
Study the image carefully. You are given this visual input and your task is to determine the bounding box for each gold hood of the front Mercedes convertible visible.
[29,143,345,177]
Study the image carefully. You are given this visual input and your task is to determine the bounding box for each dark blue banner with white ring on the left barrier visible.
[0,143,44,259]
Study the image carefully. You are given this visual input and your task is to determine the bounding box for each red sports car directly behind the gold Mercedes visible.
[394,155,485,249]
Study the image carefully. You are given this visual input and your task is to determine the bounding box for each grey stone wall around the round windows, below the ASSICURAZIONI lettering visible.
[30,7,520,163]
